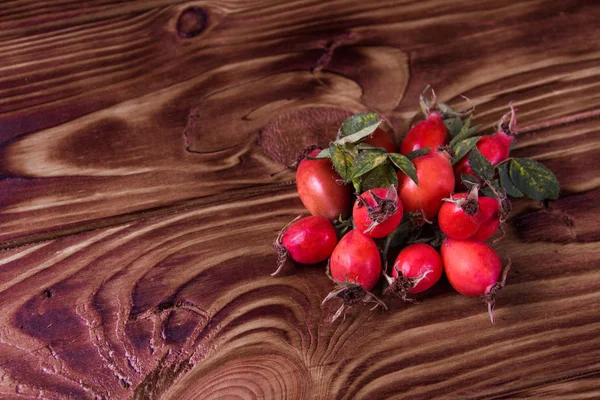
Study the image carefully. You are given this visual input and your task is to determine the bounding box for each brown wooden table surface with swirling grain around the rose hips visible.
[0,0,600,399]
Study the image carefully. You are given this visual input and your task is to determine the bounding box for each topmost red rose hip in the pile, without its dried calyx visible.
[400,112,450,154]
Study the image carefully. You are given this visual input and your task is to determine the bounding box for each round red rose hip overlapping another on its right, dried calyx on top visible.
[438,187,482,239]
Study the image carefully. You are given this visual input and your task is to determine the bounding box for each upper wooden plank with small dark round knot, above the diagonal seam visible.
[0,0,600,247]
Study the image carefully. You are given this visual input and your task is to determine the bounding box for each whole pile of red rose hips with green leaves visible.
[273,90,559,323]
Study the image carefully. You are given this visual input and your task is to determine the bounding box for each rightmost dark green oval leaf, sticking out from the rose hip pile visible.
[509,158,560,200]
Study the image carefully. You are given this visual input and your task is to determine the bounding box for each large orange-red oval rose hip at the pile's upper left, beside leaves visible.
[296,149,351,220]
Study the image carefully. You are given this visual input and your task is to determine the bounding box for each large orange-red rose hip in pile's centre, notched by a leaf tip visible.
[398,151,454,219]
